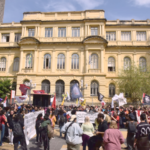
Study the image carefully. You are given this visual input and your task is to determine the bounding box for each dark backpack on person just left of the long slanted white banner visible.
[13,122,23,137]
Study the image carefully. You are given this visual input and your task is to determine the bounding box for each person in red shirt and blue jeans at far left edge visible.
[0,110,7,146]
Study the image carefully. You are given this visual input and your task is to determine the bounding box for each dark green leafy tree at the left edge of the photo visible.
[0,78,12,99]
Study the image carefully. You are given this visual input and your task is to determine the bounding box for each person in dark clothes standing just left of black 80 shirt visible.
[126,113,137,150]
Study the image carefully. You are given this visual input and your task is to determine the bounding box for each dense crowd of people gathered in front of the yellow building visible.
[0,104,150,150]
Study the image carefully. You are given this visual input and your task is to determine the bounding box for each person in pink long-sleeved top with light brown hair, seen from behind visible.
[103,121,125,150]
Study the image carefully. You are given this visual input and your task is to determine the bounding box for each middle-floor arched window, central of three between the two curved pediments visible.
[57,54,65,69]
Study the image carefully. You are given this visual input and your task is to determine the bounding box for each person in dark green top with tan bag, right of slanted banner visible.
[40,114,53,150]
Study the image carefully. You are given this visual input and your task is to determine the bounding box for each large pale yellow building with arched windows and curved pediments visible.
[0,10,150,103]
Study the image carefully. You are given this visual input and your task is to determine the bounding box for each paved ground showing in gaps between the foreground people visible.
[0,126,127,150]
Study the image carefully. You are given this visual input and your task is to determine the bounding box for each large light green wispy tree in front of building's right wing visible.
[117,63,150,102]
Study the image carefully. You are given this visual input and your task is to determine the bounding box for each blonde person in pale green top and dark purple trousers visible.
[81,117,94,150]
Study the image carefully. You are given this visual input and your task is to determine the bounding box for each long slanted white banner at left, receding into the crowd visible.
[24,110,44,145]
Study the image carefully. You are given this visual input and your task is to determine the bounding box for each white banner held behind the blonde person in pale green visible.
[68,111,98,123]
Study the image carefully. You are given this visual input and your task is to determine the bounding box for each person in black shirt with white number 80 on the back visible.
[134,113,150,150]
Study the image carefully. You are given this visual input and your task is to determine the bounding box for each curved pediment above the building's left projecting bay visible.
[18,37,40,45]
